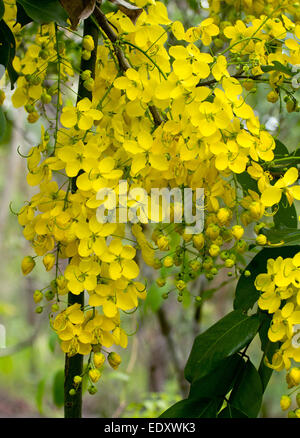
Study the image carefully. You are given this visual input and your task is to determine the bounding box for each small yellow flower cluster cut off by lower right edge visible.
[255,253,300,418]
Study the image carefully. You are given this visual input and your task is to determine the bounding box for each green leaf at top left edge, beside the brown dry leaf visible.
[17,0,68,25]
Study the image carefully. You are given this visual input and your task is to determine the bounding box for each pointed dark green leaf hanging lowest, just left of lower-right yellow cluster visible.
[229,360,263,418]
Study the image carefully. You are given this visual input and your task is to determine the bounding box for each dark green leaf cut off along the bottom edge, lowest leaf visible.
[159,398,220,418]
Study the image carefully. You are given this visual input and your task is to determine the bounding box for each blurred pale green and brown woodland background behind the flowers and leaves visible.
[0,0,300,418]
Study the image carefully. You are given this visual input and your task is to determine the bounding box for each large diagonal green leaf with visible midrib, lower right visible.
[185,310,259,382]
